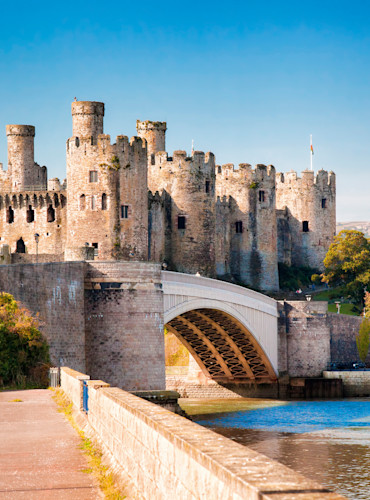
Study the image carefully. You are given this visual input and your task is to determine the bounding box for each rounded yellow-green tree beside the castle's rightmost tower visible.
[322,230,370,302]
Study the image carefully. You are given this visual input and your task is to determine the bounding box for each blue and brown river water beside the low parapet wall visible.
[180,398,370,500]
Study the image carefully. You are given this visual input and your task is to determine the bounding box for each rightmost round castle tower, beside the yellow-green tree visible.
[276,170,336,270]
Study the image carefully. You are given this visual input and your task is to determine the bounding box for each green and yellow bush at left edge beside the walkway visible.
[0,293,49,384]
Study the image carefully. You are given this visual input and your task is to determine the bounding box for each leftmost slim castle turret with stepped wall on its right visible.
[6,125,47,192]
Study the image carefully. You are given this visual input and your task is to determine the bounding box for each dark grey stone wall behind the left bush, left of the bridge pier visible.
[0,262,85,370]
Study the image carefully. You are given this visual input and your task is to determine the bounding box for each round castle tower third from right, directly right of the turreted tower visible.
[150,151,216,277]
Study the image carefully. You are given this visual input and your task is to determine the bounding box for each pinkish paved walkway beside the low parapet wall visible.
[0,389,104,500]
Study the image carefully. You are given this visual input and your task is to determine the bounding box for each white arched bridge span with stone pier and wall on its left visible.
[0,261,278,390]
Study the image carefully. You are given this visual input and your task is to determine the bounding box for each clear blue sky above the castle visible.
[0,0,370,221]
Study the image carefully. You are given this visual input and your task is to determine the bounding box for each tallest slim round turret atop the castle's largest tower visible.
[72,101,104,140]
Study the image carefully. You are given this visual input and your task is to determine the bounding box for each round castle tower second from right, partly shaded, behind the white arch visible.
[216,164,279,290]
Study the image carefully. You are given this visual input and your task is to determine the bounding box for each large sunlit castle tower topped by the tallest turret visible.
[65,101,148,260]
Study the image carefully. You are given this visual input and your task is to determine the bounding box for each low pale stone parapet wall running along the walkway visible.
[61,368,343,500]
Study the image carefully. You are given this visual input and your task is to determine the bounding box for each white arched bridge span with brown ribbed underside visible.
[162,271,278,383]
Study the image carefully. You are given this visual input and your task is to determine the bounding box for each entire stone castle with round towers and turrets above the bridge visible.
[0,101,336,290]
